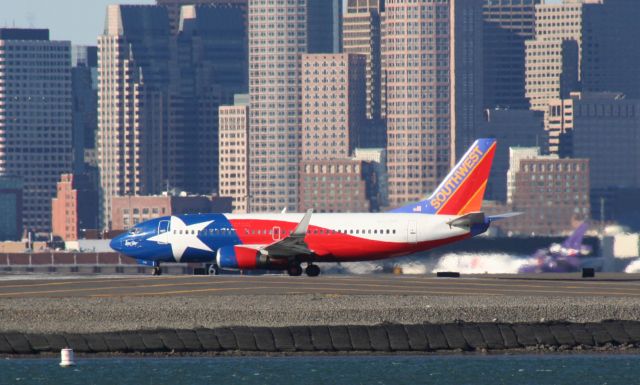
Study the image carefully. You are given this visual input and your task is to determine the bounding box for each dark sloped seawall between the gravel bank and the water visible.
[0,321,640,355]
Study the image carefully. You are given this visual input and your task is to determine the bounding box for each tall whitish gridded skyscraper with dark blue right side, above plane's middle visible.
[249,0,340,212]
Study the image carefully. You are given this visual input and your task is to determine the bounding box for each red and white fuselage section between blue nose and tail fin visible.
[225,213,472,262]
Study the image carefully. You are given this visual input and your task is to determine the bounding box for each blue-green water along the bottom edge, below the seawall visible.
[0,355,640,385]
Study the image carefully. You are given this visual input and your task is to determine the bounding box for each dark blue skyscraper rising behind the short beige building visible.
[167,5,248,194]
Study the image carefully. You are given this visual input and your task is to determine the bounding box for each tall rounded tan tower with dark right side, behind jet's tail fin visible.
[383,0,482,206]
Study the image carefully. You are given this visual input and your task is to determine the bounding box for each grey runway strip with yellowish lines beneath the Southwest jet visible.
[0,274,640,301]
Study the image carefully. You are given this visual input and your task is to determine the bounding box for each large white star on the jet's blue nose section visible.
[149,216,214,262]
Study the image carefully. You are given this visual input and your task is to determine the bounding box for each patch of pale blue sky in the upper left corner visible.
[0,0,155,45]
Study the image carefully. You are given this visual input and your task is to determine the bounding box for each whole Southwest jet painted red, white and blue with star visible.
[111,139,513,277]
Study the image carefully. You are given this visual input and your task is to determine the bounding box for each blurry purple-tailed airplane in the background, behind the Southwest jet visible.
[518,222,592,273]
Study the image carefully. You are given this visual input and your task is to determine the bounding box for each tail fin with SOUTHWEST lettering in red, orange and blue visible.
[390,139,496,215]
